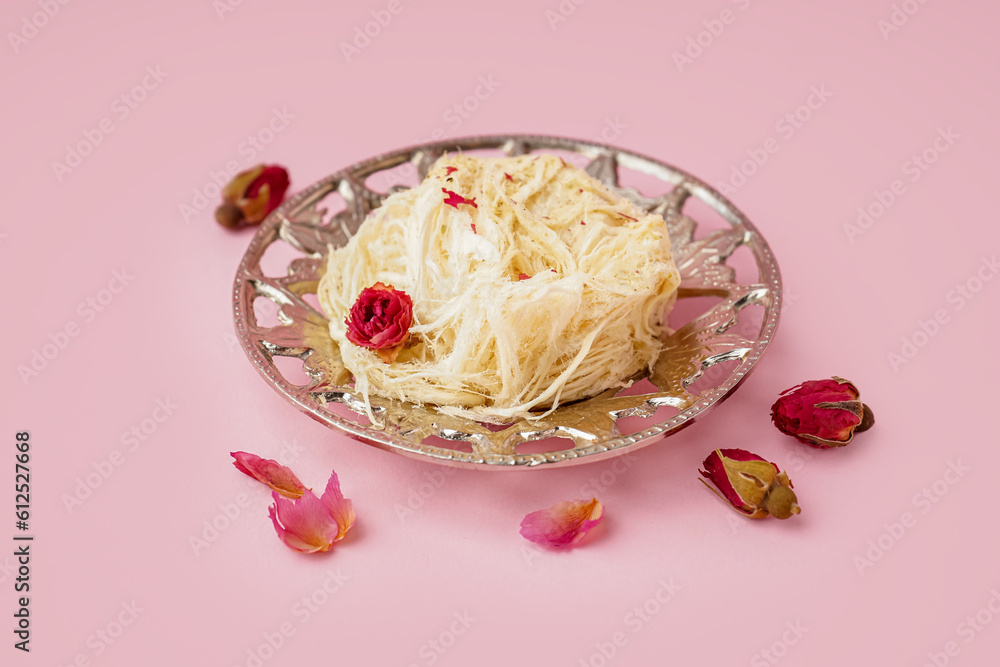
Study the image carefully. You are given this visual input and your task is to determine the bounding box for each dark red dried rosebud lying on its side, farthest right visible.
[771,376,875,449]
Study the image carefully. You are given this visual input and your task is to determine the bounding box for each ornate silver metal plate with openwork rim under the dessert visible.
[233,135,781,469]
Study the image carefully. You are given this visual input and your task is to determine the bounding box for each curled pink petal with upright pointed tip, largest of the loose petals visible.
[268,472,355,553]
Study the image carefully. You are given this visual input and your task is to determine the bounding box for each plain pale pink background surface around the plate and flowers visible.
[0,0,1000,667]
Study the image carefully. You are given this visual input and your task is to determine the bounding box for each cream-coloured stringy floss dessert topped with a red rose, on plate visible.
[318,154,680,423]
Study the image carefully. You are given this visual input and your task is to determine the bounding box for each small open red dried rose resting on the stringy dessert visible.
[344,282,413,364]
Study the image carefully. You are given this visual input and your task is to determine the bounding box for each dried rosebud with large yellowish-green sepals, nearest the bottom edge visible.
[698,449,799,519]
